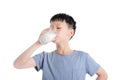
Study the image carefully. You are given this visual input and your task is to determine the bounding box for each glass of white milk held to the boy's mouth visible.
[39,30,56,44]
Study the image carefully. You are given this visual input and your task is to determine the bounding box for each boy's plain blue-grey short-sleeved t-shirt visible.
[33,50,100,80]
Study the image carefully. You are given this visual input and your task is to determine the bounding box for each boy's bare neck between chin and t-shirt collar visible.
[56,43,73,54]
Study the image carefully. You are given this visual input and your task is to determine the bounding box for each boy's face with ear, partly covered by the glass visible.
[50,21,74,43]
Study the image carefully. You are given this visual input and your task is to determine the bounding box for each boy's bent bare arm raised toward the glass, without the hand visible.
[14,41,42,69]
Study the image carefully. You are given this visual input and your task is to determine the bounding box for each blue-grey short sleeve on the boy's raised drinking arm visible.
[33,52,44,71]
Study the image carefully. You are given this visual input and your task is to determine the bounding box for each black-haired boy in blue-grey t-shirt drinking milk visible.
[14,13,107,80]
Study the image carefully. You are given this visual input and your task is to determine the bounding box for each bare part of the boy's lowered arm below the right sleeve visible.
[96,67,108,80]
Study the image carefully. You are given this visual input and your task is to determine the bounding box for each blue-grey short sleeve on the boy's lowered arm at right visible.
[86,54,100,76]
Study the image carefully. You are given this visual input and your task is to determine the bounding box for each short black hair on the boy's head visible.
[50,13,76,38]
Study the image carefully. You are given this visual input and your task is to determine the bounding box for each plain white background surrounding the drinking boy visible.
[0,0,120,80]
